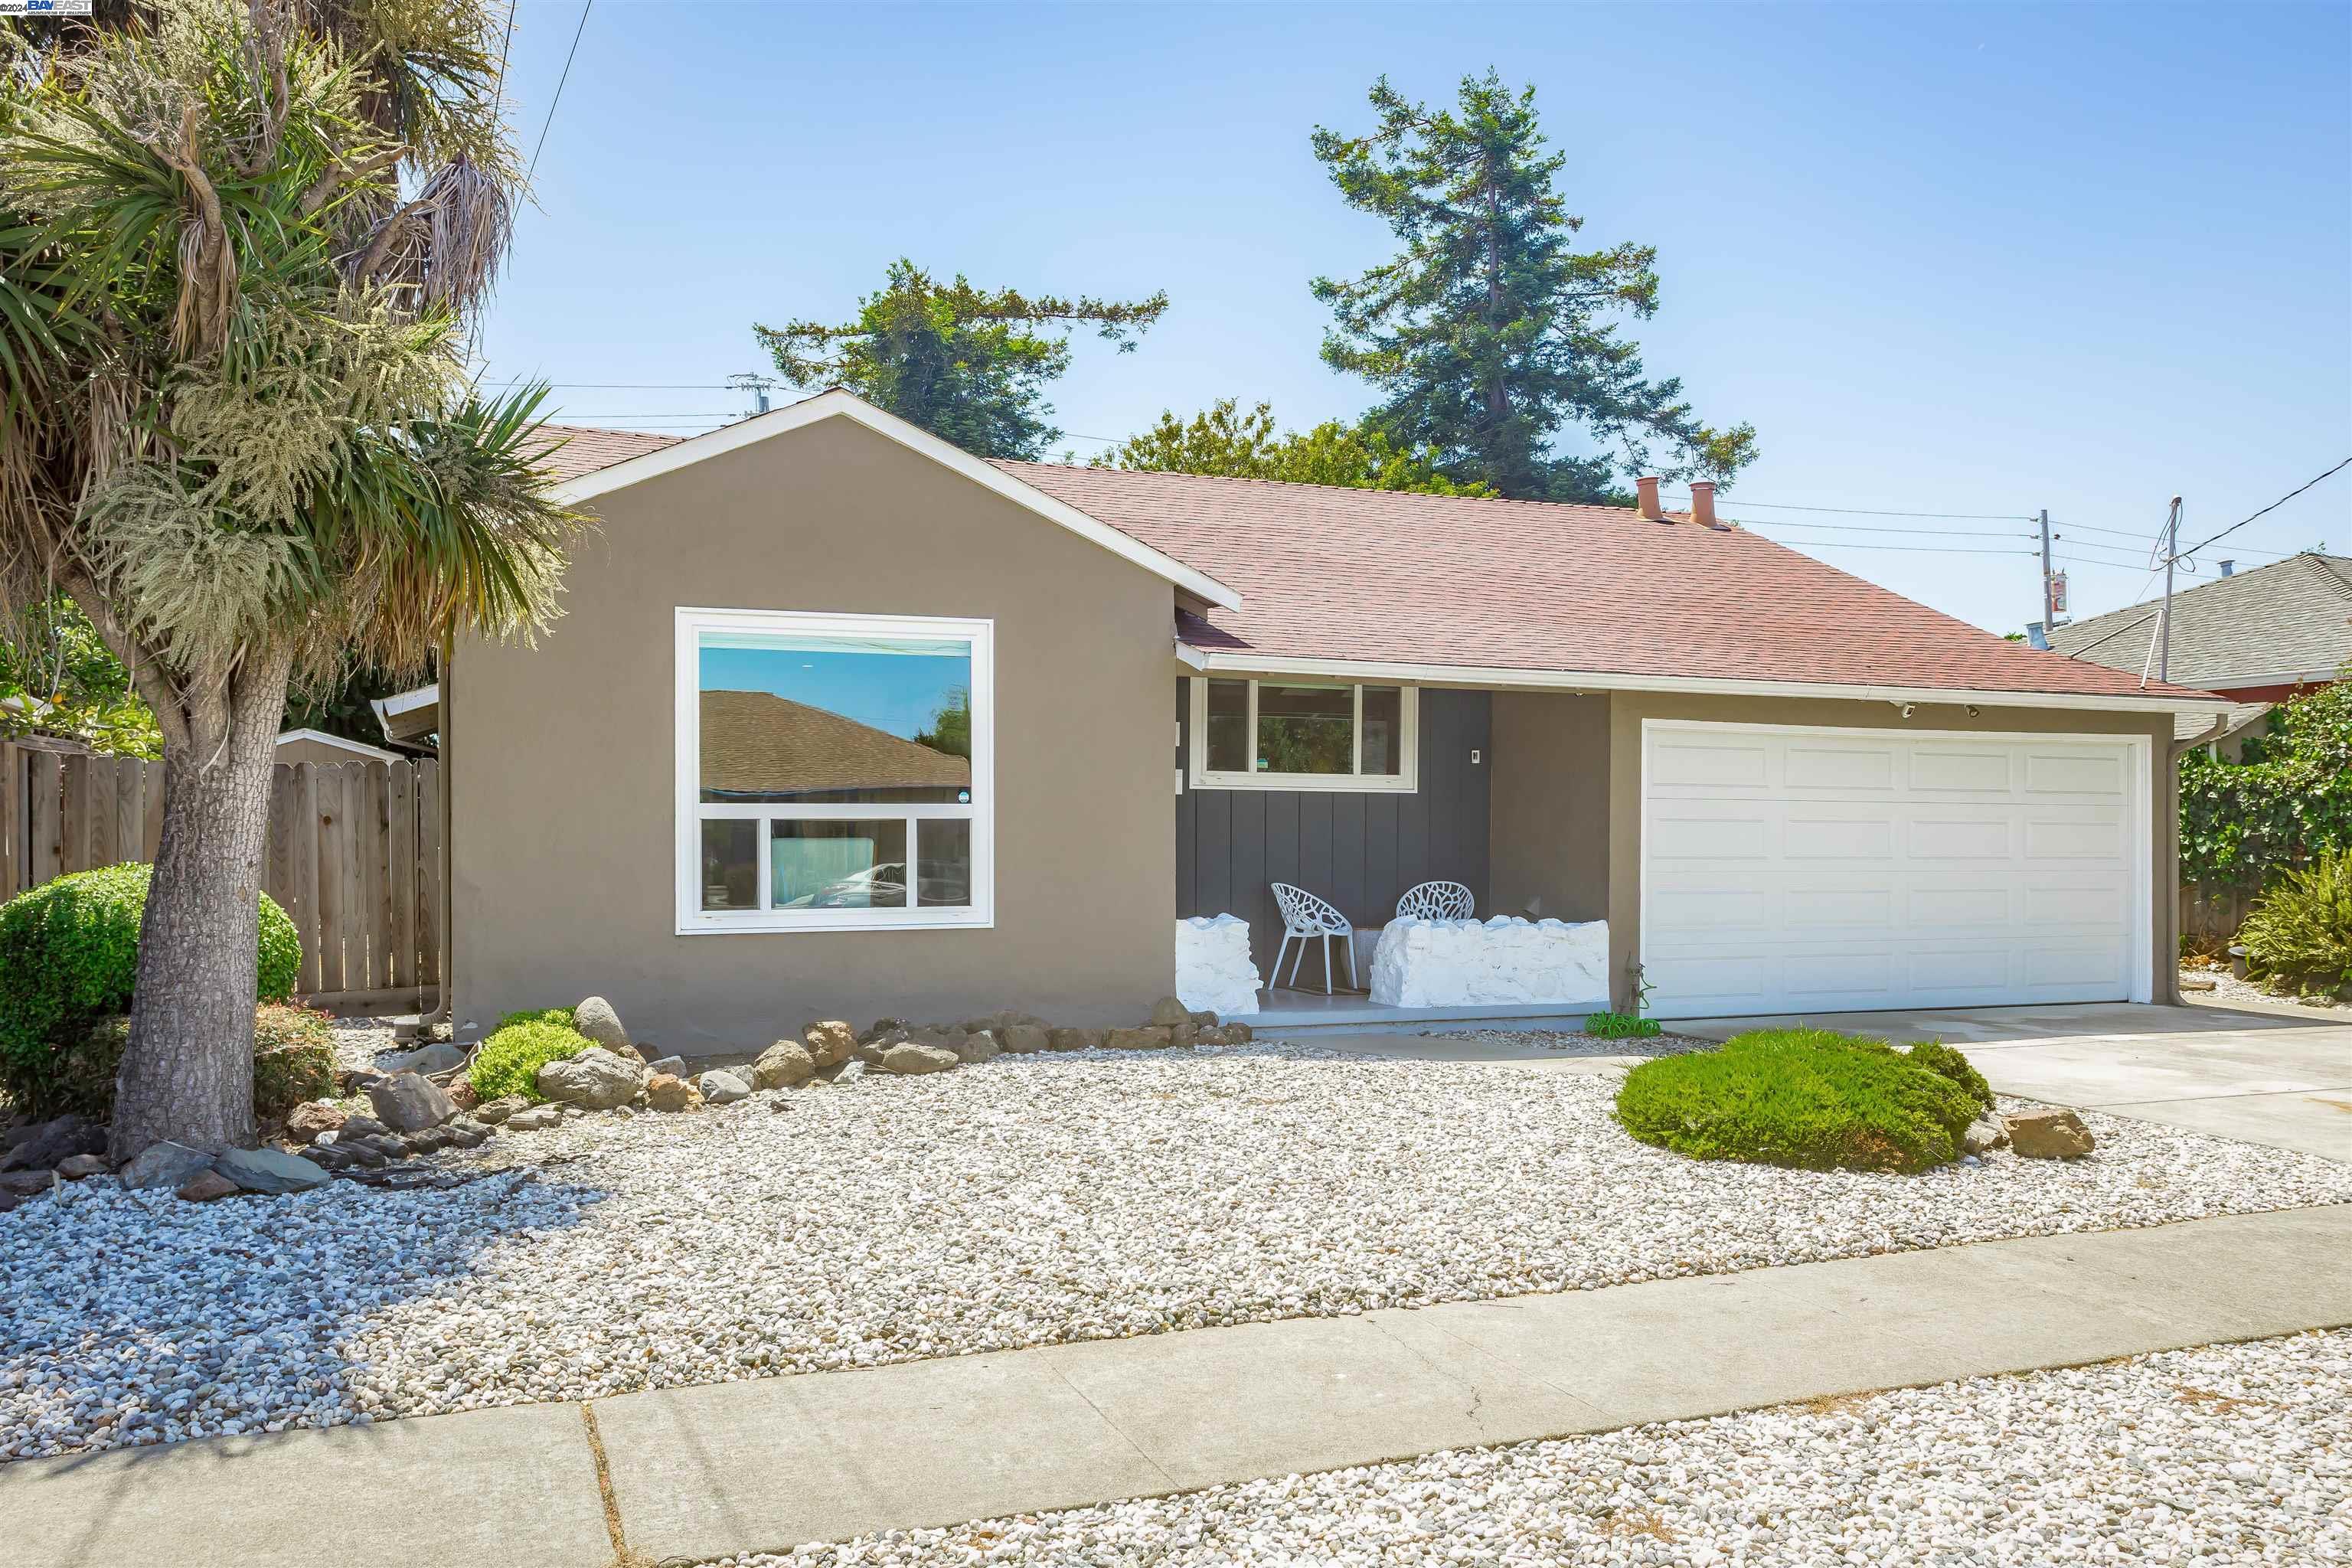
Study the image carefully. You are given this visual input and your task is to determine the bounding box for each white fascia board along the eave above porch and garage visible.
[1176,642,2242,714]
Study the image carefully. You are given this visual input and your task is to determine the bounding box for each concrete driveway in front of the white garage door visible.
[1665,1001,2352,1161]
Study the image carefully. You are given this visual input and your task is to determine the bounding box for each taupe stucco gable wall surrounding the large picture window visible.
[445,419,1176,1050]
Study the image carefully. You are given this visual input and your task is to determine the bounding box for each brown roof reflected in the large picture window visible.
[701,691,972,799]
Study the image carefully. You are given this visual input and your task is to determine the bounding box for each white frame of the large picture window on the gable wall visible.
[673,606,998,936]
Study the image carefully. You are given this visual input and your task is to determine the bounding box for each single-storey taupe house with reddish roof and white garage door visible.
[435,393,2225,1050]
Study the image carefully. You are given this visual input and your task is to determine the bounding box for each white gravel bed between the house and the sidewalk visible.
[0,1046,2352,1458]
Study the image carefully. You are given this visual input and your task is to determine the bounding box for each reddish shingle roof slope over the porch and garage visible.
[998,463,2220,696]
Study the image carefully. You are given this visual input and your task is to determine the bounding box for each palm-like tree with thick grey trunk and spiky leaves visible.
[0,0,581,1159]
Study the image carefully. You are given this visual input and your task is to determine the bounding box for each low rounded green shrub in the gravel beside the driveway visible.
[1619,1030,1978,1171]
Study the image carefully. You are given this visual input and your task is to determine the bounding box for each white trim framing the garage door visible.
[1635,720,2157,1018]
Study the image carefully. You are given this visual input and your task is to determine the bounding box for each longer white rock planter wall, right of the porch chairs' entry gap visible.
[1371,914,1609,1011]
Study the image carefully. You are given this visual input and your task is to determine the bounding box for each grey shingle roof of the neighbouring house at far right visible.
[2051,555,2352,689]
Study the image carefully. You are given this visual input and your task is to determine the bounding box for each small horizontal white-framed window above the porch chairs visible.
[1193,677,1420,792]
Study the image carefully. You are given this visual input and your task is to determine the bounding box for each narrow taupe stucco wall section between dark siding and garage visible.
[1487,691,1609,920]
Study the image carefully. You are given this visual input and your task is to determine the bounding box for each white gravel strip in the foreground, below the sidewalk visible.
[724,1333,2352,1568]
